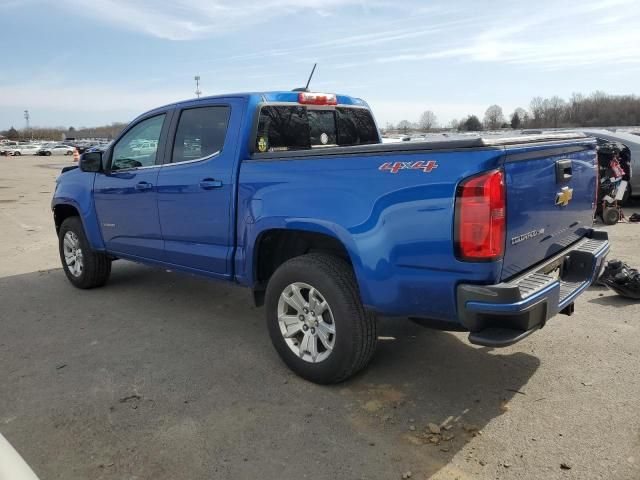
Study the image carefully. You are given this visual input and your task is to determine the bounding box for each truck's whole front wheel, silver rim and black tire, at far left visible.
[58,217,111,288]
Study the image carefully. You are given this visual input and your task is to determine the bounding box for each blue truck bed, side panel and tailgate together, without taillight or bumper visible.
[236,134,595,321]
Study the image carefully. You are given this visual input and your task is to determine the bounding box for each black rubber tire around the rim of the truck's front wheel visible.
[58,217,111,289]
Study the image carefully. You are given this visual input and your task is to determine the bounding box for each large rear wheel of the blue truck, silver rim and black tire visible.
[265,253,377,384]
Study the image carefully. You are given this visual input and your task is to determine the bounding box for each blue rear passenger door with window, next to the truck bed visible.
[158,99,243,277]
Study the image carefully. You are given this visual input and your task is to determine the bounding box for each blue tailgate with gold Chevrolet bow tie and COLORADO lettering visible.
[501,139,596,280]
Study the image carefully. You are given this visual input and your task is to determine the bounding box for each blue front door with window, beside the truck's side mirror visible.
[94,112,169,260]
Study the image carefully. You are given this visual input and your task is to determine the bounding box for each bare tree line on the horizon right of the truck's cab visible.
[382,91,640,133]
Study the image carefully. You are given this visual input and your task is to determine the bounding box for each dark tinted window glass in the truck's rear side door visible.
[171,106,231,163]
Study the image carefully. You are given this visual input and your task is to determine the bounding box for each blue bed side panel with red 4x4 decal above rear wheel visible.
[236,148,503,321]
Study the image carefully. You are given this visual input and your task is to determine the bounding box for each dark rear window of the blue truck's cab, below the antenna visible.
[254,105,380,153]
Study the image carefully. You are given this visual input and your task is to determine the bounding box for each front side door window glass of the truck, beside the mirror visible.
[111,114,165,170]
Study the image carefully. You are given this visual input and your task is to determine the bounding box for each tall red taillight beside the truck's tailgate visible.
[455,170,506,262]
